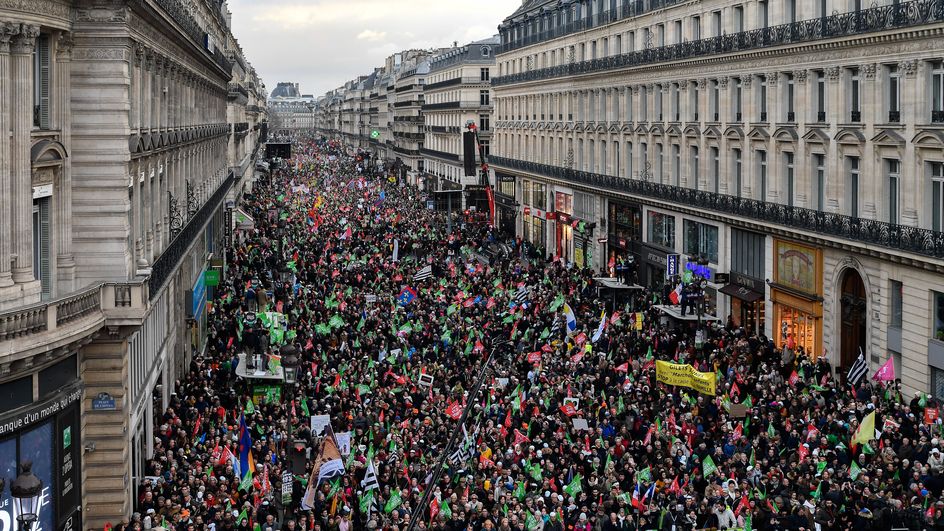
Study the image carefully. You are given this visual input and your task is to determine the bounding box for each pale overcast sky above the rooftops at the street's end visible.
[229,0,521,96]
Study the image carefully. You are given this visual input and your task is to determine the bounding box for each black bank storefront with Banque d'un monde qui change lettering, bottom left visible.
[0,378,82,531]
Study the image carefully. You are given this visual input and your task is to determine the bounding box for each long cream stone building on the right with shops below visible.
[492,0,944,395]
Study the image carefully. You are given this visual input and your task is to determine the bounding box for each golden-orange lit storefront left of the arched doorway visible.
[770,240,823,356]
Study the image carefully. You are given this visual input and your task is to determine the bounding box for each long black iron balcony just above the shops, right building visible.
[489,155,944,259]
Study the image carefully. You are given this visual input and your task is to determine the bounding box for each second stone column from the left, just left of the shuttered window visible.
[10,24,39,283]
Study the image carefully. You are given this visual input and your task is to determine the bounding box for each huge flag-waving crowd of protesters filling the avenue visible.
[131,138,944,531]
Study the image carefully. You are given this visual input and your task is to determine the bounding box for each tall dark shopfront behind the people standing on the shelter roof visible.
[606,200,642,284]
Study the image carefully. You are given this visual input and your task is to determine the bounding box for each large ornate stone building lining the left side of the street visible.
[0,0,265,530]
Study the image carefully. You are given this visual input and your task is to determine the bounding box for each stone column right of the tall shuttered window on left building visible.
[52,32,75,294]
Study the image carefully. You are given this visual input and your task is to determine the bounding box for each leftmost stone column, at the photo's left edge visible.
[0,22,20,288]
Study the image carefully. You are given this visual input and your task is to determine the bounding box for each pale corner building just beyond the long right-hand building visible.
[421,36,499,195]
